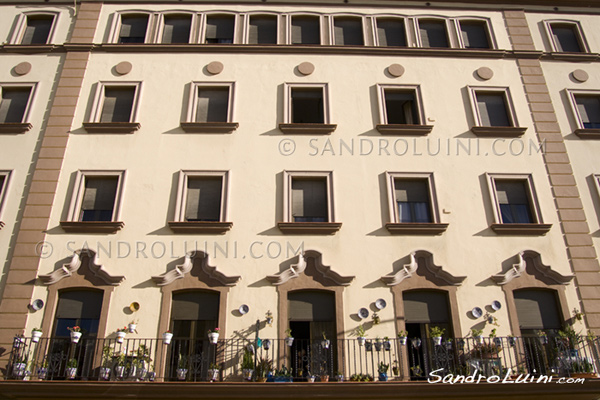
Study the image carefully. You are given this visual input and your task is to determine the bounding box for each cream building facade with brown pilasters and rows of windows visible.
[0,1,600,394]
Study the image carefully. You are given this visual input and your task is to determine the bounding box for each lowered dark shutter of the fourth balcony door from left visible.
[402,290,450,324]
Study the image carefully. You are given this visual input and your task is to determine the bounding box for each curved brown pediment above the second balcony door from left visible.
[152,251,242,286]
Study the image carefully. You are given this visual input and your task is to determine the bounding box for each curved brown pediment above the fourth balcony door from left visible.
[381,250,467,286]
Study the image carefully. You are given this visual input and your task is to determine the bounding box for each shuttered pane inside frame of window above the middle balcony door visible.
[291,178,329,222]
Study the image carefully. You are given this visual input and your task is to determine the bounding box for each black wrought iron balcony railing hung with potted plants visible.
[6,337,600,382]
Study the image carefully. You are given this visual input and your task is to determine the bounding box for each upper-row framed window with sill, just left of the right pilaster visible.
[469,87,526,136]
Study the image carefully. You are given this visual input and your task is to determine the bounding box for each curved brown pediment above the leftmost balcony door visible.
[38,249,125,286]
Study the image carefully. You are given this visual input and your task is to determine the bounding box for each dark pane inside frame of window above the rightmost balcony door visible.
[494,179,535,224]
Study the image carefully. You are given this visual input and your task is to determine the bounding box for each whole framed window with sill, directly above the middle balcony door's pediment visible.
[279,171,342,234]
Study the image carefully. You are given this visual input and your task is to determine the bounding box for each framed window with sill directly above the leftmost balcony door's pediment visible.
[61,171,125,233]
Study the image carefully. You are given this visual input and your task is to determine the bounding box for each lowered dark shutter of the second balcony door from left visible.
[171,291,220,320]
